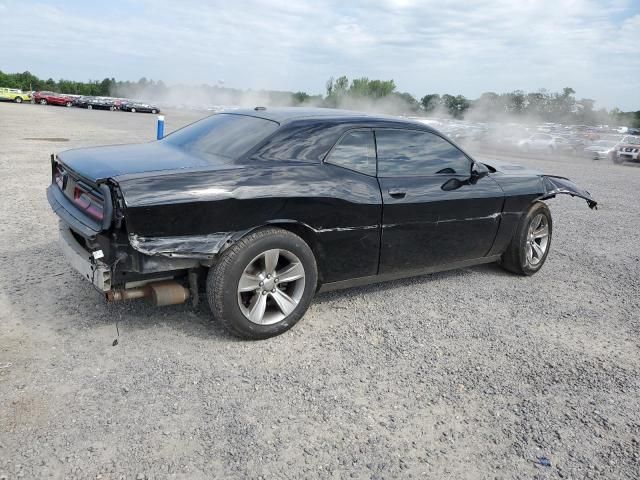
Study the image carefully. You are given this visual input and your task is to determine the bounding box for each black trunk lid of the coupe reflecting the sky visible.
[58,142,231,183]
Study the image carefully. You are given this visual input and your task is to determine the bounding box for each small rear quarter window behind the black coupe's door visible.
[326,130,376,176]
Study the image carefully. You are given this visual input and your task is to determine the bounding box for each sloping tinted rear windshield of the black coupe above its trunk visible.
[162,113,279,158]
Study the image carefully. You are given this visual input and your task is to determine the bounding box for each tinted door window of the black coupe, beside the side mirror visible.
[376,130,471,177]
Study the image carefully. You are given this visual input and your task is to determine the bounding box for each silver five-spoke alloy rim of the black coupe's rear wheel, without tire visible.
[237,249,305,325]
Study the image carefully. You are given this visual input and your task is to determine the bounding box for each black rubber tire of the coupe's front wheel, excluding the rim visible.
[500,202,553,275]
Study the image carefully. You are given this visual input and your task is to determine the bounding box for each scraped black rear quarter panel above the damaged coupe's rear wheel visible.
[116,161,382,281]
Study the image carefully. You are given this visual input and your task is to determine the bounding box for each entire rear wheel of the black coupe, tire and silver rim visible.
[207,228,318,340]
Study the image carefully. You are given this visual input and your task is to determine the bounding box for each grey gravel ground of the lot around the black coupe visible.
[0,104,640,479]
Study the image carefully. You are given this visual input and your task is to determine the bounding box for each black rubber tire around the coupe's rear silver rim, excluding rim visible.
[207,227,318,340]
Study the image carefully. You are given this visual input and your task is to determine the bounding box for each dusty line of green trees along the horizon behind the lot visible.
[0,71,640,127]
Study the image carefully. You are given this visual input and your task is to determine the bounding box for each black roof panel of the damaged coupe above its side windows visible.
[225,107,432,126]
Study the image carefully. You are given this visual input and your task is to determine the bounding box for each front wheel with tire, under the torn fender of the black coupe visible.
[501,202,553,275]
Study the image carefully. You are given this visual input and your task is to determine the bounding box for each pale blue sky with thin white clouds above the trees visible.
[0,0,640,111]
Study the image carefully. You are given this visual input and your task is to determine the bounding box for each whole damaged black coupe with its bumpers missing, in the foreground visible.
[47,107,596,338]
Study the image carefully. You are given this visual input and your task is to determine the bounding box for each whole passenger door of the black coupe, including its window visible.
[375,129,504,274]
